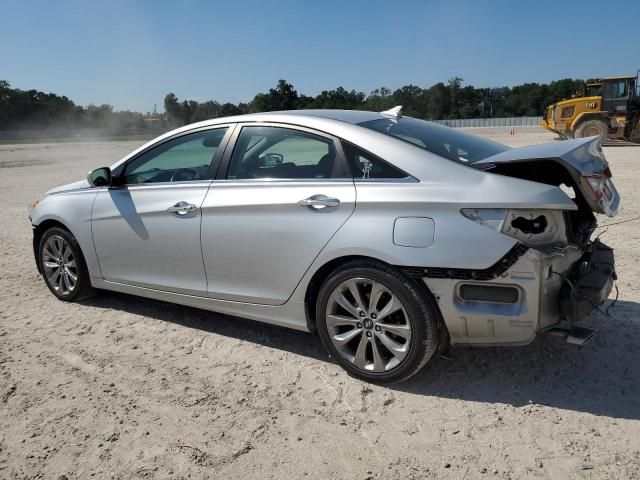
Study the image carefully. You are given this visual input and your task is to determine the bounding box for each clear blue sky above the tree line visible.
[0,0,640,111]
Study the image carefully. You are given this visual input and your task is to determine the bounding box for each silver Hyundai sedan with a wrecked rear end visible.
[31,107,620,382]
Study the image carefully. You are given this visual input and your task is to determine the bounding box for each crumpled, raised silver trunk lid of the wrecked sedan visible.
[472,137,620,217]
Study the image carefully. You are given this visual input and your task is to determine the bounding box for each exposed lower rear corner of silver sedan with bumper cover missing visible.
[416,241,616,345]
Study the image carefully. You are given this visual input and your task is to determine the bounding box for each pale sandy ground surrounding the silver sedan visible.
[0,128,640,480]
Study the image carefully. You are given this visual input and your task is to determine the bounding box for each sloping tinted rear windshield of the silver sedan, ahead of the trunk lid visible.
[358,117,509,165]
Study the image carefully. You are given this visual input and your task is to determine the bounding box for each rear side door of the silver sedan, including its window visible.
[202,124,356,305]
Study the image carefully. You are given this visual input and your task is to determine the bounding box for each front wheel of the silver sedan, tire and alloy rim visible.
[38,227,93,302]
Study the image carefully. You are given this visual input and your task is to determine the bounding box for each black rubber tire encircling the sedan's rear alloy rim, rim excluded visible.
[316,265,438,383]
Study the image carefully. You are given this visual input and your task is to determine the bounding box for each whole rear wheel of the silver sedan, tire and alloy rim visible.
[316,260,441,383]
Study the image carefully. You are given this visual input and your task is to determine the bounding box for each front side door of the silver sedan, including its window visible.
[91,128,227,296]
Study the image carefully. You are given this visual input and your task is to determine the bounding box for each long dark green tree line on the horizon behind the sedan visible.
[0,77,583,132]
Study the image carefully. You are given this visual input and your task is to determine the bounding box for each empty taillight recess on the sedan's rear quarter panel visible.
[461,208,567,248]
